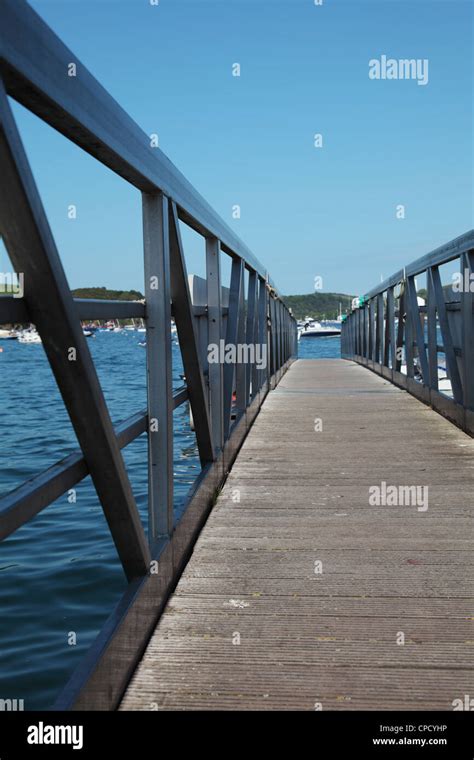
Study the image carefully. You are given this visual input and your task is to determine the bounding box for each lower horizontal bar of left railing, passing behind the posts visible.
[0,387,188,541]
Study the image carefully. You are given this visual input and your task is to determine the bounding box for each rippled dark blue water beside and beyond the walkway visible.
[0,332,340,710]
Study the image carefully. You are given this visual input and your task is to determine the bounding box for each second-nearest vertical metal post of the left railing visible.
[206,237,224,456]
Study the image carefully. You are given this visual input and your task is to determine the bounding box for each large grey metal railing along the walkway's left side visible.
[0,0,297,709]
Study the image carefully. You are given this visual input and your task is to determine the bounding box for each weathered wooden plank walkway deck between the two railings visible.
[120,360,474,710]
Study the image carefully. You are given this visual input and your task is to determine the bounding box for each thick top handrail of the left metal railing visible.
[0,0,278,290]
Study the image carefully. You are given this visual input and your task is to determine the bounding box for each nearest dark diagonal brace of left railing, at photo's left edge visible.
[0,82,149,580]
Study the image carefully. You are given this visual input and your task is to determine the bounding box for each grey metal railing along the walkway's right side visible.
[341,230,474,435]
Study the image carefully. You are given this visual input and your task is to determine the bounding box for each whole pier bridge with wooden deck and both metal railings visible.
[0,0,474,710]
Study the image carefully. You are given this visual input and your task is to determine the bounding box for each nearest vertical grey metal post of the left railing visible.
[143,193,173,544]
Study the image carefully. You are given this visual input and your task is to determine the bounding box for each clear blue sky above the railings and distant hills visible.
[0,0,473,293]
